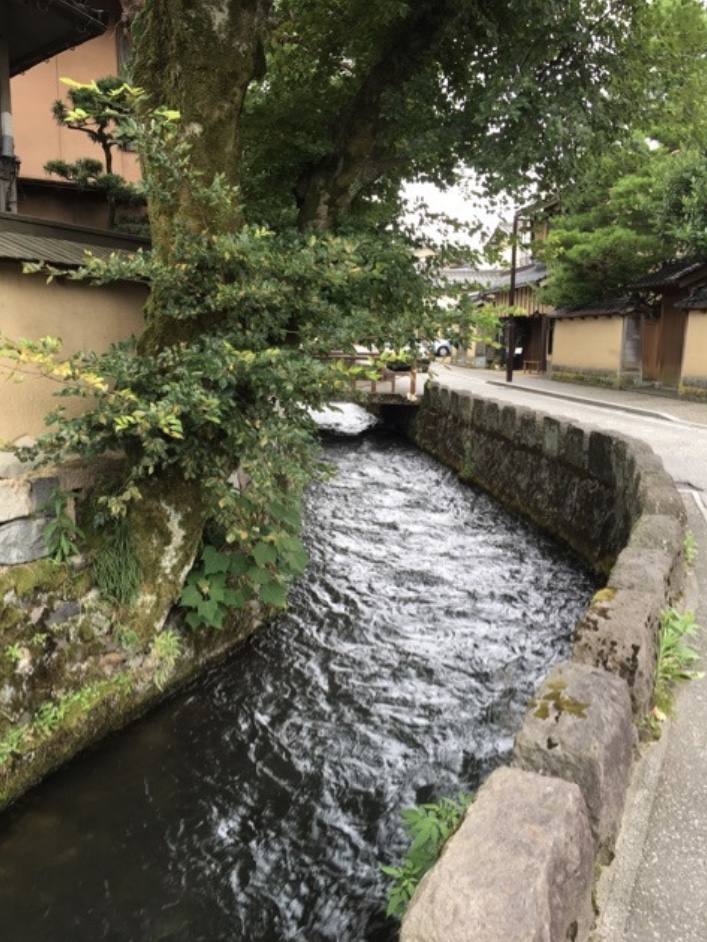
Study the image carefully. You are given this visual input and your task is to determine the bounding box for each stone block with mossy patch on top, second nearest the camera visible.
[514,662,636,863]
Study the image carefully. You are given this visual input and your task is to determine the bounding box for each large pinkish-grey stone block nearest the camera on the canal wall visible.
[400,768,594,942]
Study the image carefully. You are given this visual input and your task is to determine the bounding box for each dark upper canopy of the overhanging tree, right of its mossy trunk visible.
[242,0,642,225]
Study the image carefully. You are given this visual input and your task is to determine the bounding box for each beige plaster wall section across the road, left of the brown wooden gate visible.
[552,317,623,373]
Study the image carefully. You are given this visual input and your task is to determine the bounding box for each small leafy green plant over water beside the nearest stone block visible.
[381,792,474,919]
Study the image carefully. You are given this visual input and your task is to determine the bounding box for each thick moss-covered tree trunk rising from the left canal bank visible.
[115,0,270,630]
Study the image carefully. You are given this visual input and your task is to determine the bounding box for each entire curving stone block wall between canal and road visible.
[401,384,685,942]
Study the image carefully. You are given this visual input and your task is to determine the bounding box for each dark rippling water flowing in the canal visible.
[0,436,593,942]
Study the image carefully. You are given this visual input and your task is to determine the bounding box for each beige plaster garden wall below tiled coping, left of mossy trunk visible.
[0,262,147,442]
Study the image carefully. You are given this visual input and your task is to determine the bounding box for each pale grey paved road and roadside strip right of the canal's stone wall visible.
[420,365,707,942]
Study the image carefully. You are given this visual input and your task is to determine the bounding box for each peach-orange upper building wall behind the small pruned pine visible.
[11,27,139,180]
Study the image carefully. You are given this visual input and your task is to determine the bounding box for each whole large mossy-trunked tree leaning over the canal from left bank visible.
[16,0,660,636]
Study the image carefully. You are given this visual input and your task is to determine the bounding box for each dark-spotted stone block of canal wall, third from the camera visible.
[572,584,666,717]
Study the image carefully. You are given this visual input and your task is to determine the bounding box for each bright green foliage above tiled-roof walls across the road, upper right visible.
[538,0,707,307]
